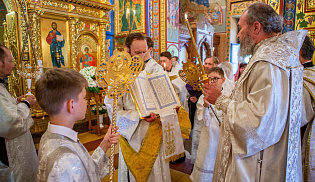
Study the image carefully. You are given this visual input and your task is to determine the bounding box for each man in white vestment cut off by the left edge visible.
[0,45,38,182]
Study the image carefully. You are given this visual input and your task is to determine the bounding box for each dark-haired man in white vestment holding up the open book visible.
[104,33,171,182]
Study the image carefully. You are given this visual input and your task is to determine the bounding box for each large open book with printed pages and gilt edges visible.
[130,72,181,118]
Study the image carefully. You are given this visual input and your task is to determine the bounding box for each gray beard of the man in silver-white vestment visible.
[239,28,255,60]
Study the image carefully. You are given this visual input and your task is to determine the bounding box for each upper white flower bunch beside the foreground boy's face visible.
[79,66,100,93]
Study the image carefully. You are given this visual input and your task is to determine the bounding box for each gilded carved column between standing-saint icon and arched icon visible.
[69,17,78,70]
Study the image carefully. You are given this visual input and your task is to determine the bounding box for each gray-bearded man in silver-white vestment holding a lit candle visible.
[204,3,307,181]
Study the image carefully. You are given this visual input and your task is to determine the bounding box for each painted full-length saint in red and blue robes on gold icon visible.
[46,22,65,68]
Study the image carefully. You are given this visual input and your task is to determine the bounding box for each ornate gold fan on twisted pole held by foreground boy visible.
[95,50,144,182]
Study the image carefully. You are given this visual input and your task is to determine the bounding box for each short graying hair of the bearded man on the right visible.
[246,3,283,35]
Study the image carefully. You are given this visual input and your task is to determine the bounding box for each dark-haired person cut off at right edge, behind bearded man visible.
[300,36,315,182]
